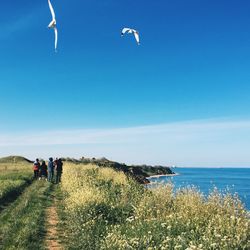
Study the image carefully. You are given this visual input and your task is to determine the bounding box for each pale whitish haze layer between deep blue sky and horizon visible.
[0,120,250,166]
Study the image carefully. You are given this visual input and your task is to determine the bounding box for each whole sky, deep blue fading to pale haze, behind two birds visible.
[0,0,250,166]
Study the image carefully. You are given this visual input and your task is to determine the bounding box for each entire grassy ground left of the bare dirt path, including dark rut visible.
[0,157,51,249]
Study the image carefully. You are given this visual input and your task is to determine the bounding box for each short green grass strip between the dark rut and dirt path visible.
[0,181,51,249]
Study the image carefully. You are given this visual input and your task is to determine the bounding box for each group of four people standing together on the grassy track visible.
[33,157,63,183]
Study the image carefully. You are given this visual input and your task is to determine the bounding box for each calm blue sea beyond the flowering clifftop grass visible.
[150,168,250,210]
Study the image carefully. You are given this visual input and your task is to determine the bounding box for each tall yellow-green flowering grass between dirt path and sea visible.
[60,164,250,250]
